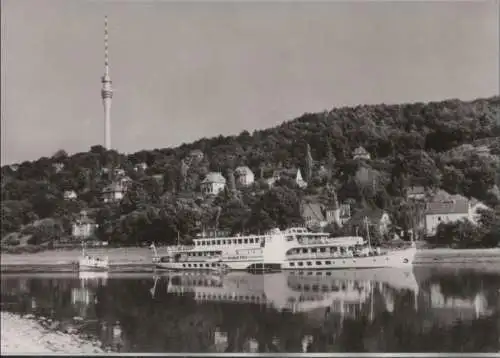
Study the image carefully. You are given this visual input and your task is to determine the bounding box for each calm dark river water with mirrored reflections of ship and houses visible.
[1,267,500,353]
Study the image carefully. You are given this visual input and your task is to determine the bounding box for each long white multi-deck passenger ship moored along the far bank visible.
[151,227,417,271]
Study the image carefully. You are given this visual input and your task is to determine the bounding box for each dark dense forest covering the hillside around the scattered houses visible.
[1,96,500,246]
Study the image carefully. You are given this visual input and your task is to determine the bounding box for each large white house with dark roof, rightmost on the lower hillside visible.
[425,190,489,236]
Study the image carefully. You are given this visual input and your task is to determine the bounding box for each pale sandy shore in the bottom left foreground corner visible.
[1,312,105,355]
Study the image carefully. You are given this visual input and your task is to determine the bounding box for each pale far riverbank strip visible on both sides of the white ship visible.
[0,247,500,272]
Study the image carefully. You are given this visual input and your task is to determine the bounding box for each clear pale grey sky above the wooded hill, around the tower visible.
[1,0,500,165]
